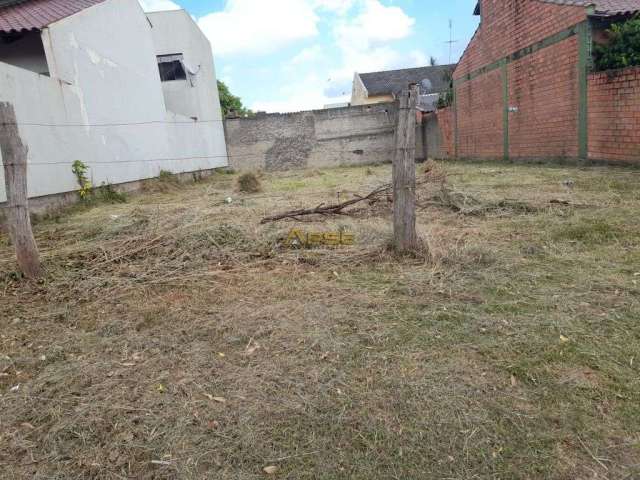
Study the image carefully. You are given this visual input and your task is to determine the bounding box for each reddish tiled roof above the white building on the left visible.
[0,0,105,33]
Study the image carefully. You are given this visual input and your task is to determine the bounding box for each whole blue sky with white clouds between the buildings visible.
[140,0,478,112]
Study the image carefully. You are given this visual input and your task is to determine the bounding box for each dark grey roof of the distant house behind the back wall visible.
[358,65,456,96]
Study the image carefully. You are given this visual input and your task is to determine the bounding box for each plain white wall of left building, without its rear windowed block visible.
[0,0,227,202]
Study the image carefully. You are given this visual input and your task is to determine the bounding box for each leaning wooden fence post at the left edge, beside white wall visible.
[0,102,42,278]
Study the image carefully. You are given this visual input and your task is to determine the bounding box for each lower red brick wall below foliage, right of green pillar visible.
[589,67,640,163]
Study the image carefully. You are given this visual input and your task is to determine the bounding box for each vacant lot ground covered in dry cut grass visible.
[0,163,640,480]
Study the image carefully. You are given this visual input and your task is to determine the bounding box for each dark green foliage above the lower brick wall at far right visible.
[593,17,640,70]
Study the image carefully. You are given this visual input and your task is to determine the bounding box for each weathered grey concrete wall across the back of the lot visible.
[225,103,440,171]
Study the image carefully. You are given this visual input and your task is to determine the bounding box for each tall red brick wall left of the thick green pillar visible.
[454,0,587,158]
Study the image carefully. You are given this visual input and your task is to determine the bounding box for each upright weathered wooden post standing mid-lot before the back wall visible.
[393,85,419,252]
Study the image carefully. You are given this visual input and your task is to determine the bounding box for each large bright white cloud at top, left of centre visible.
[198,0,319,56]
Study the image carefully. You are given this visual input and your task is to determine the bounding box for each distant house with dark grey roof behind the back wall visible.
[351,65,455,108]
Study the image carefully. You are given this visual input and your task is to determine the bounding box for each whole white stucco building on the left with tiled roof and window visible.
[0,0,228,201]
